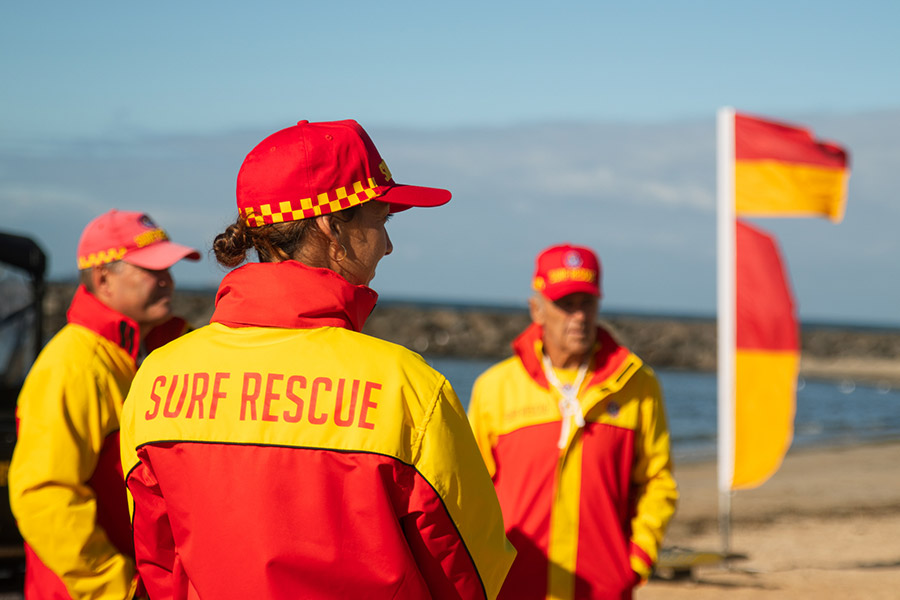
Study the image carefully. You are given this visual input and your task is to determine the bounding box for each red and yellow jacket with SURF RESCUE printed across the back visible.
[122,261,514,600]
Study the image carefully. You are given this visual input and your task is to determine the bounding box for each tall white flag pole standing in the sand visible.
[716,107,736,556]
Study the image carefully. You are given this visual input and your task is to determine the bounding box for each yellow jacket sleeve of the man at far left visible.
[9,358,135,600]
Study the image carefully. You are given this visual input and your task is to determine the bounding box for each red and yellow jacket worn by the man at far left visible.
[9,286,186,600]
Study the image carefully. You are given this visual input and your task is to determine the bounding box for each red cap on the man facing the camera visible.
[532,244,603,301]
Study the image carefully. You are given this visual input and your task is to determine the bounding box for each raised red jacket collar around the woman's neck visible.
[210,260,378,331]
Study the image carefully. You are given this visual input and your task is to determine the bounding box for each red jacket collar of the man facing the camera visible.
[512,323,642,389]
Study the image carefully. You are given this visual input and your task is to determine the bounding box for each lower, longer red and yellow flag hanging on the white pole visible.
[731,220,800,489]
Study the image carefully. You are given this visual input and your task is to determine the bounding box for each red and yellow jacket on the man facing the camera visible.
[469,325,678,600]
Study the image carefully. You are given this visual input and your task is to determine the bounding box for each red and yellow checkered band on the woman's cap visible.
[240,178,385,227]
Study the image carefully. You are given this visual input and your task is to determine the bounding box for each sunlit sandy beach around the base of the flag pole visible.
[636,441,900,600]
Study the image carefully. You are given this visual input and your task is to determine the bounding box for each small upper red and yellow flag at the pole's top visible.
[734,113,850,223]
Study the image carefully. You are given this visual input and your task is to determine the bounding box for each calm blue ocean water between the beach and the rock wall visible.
[426,357,900,460]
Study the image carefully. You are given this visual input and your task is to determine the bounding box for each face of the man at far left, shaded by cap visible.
[95,261,175,333]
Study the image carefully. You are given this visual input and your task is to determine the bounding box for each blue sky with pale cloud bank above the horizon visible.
[0,1,900,325]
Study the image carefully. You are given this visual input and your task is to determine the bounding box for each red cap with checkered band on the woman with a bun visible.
[237,120,450,227]
